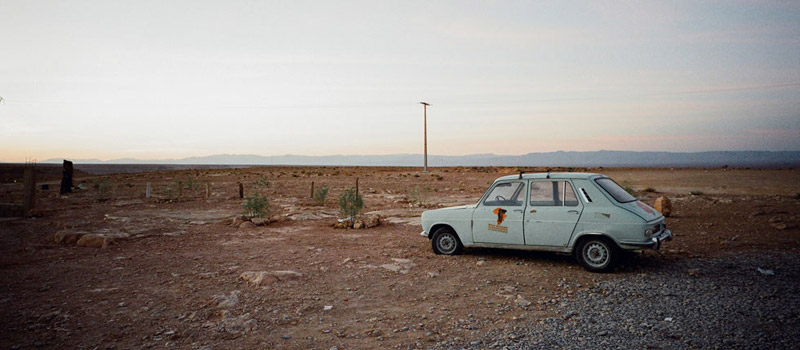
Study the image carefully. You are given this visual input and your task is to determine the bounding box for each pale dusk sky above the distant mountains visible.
[0,0,800,161]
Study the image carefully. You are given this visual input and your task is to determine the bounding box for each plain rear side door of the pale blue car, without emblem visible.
[524,180,583,247]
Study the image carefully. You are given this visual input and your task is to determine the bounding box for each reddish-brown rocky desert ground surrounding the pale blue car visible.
[0,164,800,350]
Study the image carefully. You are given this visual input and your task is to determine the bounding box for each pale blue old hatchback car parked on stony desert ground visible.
[422,173,672,272]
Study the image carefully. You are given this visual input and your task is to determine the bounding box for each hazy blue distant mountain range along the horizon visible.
[40,151,800,168]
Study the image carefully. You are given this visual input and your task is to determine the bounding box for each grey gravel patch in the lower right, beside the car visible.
[436,253,800,349]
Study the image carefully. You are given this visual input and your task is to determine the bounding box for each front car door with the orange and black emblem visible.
[472,181,527,245]
